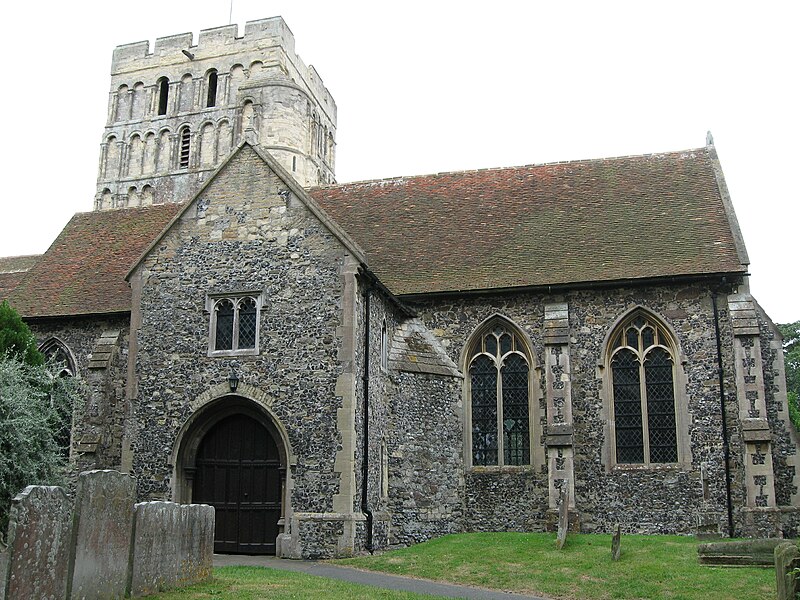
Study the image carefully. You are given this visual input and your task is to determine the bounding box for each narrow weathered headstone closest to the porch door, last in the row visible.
[178,504,214,585]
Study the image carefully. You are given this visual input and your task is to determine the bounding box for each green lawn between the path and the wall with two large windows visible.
[336,533,775,600]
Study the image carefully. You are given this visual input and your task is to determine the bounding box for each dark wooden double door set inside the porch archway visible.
[192,415,281,554]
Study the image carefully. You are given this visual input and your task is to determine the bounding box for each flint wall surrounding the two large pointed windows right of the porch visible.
[413,284,744,533]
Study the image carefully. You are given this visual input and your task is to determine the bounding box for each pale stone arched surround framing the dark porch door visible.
[172,382,296,556]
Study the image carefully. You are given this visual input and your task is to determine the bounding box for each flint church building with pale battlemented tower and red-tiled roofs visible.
[0,17,800,558]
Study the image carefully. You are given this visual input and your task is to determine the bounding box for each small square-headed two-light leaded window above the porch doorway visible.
[210,295,261,354]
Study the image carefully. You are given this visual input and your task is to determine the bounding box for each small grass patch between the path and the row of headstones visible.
[147,567,430,600]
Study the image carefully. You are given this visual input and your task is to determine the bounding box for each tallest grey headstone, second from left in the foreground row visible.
[68,471,136,600]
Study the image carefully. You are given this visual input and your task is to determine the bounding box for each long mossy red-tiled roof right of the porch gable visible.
[310,148,746,295]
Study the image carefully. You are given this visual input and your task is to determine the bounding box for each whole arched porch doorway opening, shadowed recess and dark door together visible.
[178,397,286,554]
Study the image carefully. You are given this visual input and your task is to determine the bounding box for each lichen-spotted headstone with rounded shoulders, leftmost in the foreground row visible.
[0,485,72,600]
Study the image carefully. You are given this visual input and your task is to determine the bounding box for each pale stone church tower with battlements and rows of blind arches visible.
[95,17,336,210]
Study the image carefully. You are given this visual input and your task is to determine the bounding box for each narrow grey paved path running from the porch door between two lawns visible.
[214,554,546,600]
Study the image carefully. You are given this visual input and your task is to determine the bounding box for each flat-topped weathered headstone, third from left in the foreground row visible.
[128,502,186,596]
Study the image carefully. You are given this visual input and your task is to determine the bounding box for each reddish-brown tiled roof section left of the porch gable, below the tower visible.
[9,204,180,317]
